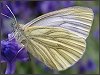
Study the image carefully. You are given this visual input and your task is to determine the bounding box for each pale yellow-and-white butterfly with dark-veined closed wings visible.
[2,6,94,71]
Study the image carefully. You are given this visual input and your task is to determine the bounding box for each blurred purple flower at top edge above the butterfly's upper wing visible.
[40,1,74,13]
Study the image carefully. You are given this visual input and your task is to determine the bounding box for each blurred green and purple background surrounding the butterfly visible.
[2,1,100,74]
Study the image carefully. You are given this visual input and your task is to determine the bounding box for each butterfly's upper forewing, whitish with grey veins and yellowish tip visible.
[25,6,93,39]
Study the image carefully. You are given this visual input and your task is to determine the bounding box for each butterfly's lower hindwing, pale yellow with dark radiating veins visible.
[24,26,86,71]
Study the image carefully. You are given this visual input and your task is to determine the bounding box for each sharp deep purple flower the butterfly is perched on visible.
[0,35,28,74]
